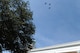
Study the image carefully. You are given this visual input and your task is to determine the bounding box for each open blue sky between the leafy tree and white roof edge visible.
[29,0,80,48]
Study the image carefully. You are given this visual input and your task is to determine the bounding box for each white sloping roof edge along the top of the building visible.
[31,40,80,52]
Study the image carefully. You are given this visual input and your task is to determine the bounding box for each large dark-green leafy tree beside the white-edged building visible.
[0,0,35,53]
